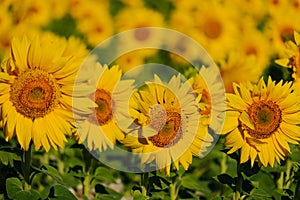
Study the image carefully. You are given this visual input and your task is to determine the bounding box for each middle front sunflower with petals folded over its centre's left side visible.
[123,75,203,175]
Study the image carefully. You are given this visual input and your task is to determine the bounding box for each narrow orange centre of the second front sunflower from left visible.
[92,89,112,125]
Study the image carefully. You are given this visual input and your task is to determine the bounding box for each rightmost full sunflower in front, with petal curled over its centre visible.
[223,78,300,167]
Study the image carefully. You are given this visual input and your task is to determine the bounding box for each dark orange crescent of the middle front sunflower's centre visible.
[149,110,182,147]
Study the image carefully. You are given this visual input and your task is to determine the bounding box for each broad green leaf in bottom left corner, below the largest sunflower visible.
[6,178,40,200]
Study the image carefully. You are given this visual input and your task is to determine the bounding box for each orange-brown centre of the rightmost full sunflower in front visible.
[247,100,281,139]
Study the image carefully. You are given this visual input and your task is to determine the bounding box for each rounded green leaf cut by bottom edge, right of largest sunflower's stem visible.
[49,185,77,200]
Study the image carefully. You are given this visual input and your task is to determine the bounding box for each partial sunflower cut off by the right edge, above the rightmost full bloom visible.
[275,31,300,81]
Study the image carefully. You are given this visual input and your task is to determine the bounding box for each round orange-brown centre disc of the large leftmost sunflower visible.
[10,69,60,118]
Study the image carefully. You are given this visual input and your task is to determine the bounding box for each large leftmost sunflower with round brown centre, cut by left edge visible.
[0,35,87,151]
